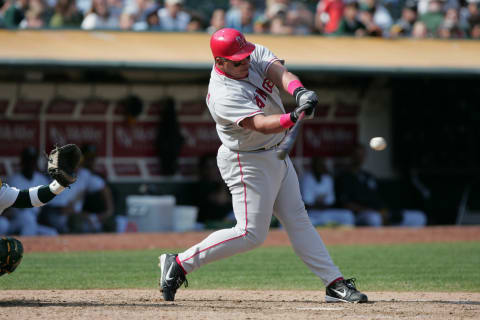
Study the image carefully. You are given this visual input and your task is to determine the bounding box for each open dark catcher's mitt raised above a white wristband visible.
[48,144,82,187]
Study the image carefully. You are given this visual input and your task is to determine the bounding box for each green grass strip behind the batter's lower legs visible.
[0,242,480,292]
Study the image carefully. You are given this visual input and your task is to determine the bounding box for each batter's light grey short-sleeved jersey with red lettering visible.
[207,44,285,151]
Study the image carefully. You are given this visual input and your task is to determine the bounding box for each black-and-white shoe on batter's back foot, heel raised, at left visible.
[158,253,188,301]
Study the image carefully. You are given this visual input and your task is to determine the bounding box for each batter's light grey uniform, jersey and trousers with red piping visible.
[177,44,342,285]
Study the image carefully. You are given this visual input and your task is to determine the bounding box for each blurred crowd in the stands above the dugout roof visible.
[0,0,480,39]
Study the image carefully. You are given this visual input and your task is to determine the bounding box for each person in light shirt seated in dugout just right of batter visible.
[300,157,355,227]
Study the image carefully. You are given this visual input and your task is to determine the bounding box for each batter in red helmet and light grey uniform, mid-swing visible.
[159,28,368,302]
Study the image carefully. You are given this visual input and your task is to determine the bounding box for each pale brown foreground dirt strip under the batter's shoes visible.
[0,289,480,320]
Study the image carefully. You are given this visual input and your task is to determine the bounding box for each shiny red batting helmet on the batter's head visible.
[210,28,255,61]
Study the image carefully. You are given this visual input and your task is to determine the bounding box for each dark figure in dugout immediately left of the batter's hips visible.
[195,154,235,229]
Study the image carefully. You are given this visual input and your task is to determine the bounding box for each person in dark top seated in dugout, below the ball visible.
[336,145,427,227]
